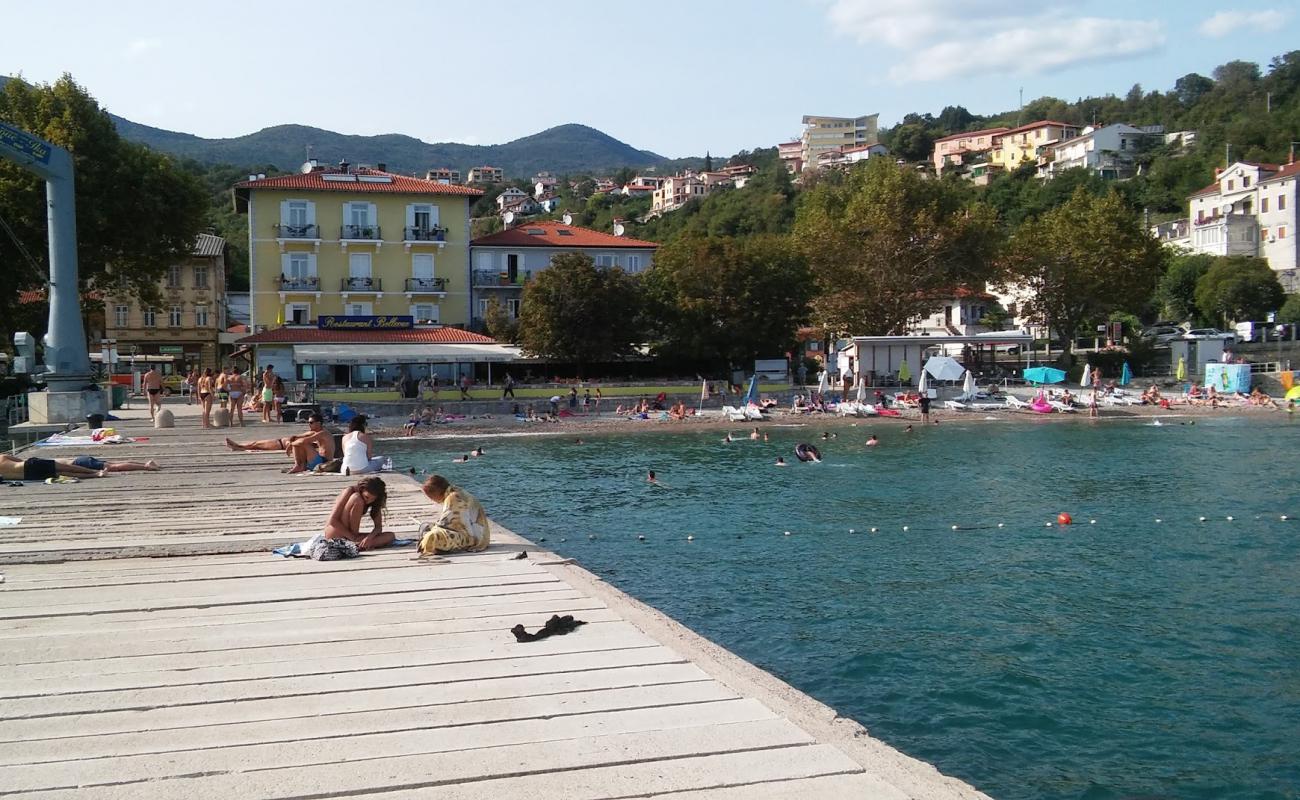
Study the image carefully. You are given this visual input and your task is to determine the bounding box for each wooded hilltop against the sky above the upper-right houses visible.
[881,51,1300,212]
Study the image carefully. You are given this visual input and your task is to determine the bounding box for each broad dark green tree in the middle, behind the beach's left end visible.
[646,234,811,366]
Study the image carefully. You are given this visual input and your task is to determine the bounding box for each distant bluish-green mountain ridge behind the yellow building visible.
[0,75,668,178]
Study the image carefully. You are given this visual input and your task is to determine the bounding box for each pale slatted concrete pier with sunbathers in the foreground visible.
[0,403,984,800]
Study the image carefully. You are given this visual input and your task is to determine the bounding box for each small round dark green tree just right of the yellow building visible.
[519,252,644,377]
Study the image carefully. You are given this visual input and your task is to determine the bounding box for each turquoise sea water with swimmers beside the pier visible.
[384,415,1300,800]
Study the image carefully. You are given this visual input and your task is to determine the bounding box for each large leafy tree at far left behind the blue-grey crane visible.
[0,75,207,341]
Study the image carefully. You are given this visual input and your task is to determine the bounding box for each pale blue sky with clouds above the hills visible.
[0,0,1300,157]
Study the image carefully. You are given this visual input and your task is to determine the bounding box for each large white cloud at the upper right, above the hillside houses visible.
[827,0,1165,82]
